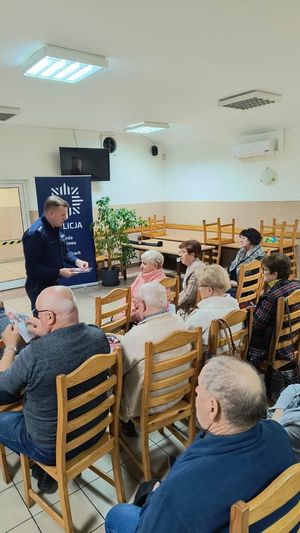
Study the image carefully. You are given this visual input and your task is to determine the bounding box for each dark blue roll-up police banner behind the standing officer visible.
[35,176,97,287]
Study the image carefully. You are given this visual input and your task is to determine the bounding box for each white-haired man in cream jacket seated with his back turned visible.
[120,282,187,436]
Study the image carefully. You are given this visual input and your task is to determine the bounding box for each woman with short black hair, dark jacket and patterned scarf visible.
[229,228,265,296]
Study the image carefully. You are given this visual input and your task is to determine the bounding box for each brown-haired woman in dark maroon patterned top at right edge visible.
[248,254,300,368]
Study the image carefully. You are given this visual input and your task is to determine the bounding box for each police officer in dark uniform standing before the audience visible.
[22,195,89,309]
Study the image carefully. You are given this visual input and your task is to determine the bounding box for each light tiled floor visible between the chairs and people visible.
[0,272,188,533]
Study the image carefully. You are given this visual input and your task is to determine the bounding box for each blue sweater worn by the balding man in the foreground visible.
[136,420,295,533]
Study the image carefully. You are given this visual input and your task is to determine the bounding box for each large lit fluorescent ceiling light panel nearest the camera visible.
[23,45,108,83]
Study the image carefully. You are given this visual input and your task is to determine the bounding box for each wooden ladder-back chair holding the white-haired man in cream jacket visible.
[120,328,202,481]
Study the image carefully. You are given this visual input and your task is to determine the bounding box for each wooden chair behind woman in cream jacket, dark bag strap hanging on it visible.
[208,307,253,359]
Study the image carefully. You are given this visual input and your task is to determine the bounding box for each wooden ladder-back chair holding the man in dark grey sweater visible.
[21,348,125,533]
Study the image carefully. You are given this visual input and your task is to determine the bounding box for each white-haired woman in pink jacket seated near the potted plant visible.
[131,250,166,322]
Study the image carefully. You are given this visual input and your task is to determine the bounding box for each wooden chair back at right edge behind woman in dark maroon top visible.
[269,289,300,368]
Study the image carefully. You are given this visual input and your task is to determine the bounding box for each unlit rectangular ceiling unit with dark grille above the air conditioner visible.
[218,90,281,110]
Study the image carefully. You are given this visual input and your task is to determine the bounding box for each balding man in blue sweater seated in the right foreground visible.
[105,355,295,533]
